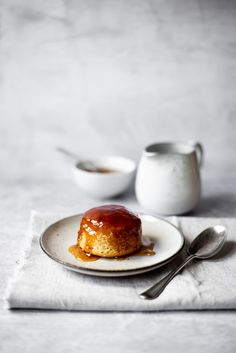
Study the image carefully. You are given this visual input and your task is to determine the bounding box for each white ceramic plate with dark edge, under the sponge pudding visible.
[40,214,184,277]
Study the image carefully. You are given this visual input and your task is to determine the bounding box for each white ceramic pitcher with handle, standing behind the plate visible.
[135,142,203,215]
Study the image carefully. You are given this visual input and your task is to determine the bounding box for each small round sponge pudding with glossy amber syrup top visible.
[78,205,142,257]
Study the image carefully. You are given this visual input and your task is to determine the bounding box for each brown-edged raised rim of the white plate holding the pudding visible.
[39,212,185,276]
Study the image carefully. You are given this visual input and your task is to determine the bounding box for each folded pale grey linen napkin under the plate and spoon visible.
[6,212,236,311]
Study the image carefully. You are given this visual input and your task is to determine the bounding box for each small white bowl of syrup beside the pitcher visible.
[73,156,136,199]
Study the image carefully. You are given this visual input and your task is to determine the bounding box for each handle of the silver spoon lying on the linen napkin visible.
[139,255,195,300]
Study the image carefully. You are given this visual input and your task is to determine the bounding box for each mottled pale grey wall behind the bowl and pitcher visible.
[0,0,236,184]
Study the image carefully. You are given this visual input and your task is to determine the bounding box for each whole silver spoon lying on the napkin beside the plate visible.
[139,225,226,300]
